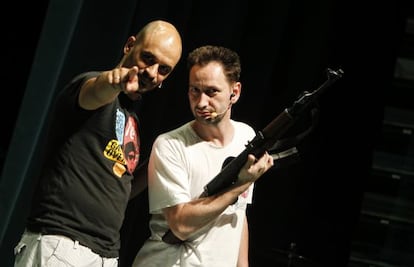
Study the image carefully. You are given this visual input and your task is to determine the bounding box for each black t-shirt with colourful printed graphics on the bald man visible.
[27,72,140,257]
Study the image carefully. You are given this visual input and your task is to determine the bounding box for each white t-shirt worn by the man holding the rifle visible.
[133,120,255,267]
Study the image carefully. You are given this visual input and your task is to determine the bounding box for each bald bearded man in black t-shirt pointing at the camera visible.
[15,20,182,267]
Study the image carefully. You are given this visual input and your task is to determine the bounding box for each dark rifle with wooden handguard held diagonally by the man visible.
[162,68,344,244]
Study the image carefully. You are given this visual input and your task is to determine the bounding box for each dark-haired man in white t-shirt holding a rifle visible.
[133,45,273,267]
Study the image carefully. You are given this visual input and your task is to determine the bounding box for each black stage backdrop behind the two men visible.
[0,0,414,267]
